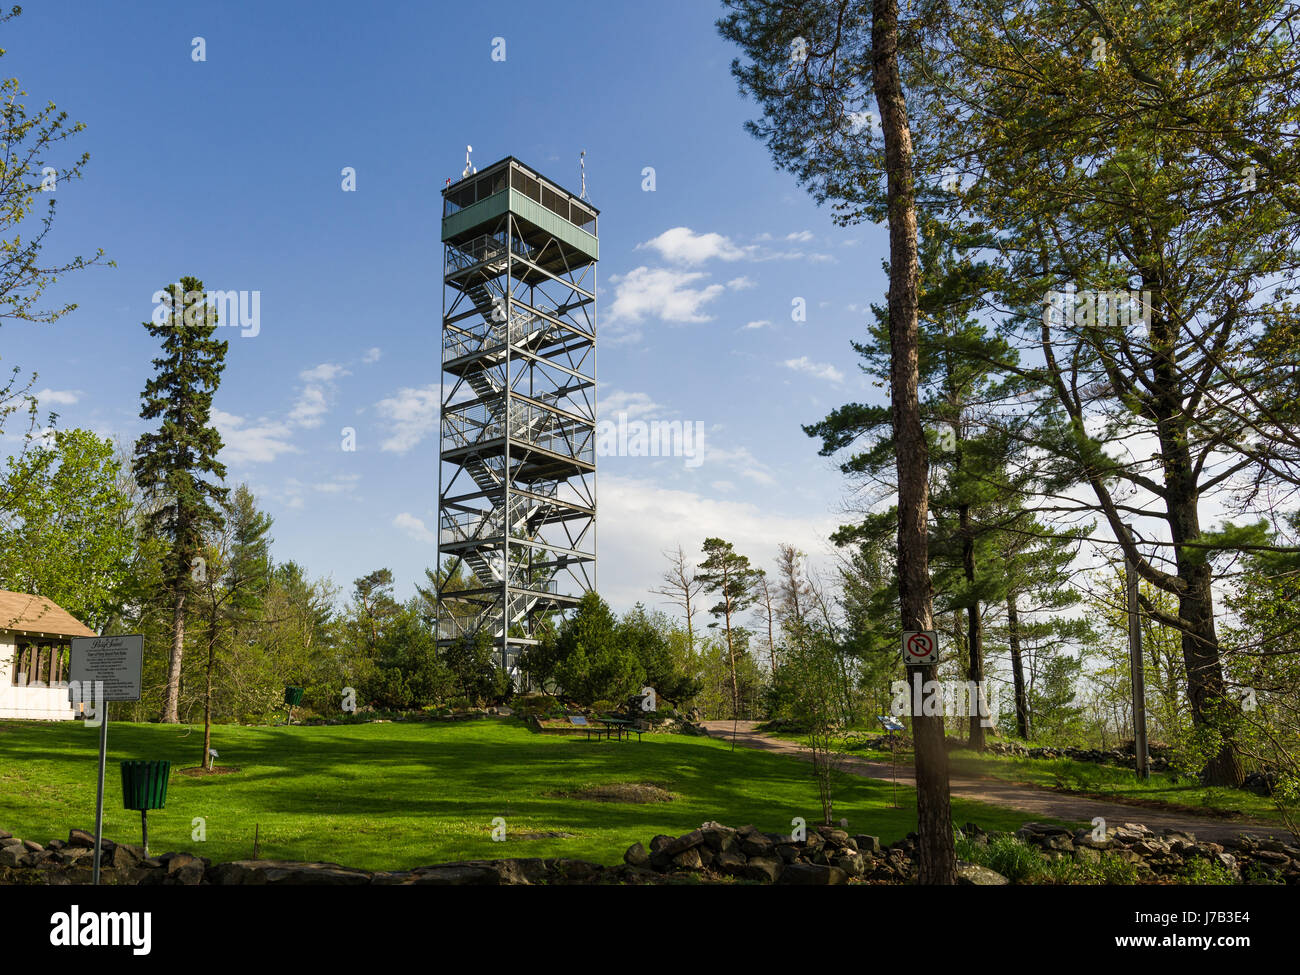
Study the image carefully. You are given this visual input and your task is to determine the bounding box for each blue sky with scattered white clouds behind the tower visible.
[0,1,887,608]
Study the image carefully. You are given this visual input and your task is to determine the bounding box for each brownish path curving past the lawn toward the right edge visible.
[705,722,1296,844]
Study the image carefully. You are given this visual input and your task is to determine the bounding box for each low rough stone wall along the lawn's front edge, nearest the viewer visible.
[0,823,1300,885]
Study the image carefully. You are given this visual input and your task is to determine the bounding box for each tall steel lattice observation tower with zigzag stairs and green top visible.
[437,157,599,672]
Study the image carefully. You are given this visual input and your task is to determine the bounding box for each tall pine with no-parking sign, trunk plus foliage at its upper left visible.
[718,0,957,884]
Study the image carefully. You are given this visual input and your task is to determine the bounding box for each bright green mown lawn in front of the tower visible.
[0,719,1066,870]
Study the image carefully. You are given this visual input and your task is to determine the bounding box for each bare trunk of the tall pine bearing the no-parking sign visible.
[871,0,957,884]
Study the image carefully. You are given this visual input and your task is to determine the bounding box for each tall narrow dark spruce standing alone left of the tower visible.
[134,277,229,723]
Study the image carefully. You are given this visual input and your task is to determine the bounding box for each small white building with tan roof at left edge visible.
[0,589,95,722]
